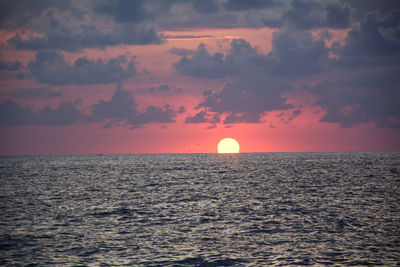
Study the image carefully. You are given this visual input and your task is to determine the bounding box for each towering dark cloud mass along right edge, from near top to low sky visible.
[311,10,400,128]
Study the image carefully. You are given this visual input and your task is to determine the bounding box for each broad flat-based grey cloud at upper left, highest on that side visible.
[7,4,161,51]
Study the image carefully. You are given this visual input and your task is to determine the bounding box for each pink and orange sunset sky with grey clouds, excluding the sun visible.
[0,0,400,155]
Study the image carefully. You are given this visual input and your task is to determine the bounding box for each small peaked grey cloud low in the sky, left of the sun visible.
[88,85,183,128]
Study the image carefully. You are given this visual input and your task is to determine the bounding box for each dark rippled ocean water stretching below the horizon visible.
[0,152,400,266]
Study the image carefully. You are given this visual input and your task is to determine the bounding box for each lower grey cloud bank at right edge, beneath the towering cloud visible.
[312,71,400,128]
